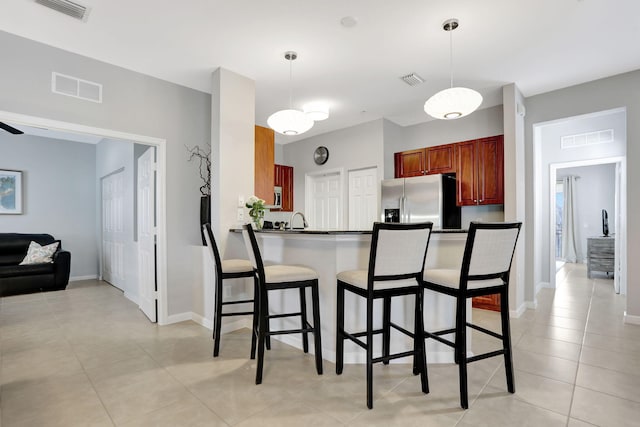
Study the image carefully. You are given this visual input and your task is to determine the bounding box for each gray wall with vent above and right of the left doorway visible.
[0,32,211,315]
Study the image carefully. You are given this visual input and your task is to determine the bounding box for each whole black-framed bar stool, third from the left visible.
[336,222,433,409]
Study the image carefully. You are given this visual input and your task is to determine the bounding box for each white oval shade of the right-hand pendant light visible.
[424,87,482,120]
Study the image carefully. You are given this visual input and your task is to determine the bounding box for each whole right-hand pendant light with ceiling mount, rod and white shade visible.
[424,18,482,120]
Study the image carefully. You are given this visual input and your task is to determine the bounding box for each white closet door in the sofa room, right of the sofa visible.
[101,170,125,290]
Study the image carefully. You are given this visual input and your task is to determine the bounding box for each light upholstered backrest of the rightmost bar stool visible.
[460,222,522,290]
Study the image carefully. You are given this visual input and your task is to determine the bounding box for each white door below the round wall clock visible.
[305,172,342,230]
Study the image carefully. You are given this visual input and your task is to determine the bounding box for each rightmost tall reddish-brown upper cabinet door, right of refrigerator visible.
[476,135,504,205]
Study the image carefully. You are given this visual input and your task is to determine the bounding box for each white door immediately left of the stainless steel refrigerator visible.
[349,168,378,230]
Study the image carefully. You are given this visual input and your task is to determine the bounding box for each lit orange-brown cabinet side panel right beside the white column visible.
[253,126,275,205]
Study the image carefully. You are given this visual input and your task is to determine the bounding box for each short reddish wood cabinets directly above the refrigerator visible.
[394,144,456,178]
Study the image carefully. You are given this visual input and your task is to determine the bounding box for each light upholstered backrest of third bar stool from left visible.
[368,222,433,291]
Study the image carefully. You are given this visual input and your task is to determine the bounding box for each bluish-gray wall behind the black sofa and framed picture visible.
[0,135,98,278]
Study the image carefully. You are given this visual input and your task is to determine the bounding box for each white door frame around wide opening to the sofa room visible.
[0,110,168,325]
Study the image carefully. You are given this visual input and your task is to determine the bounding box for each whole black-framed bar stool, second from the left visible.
[242,224,322,384]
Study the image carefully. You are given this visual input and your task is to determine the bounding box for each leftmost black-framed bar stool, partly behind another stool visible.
[202,223,258,359]
